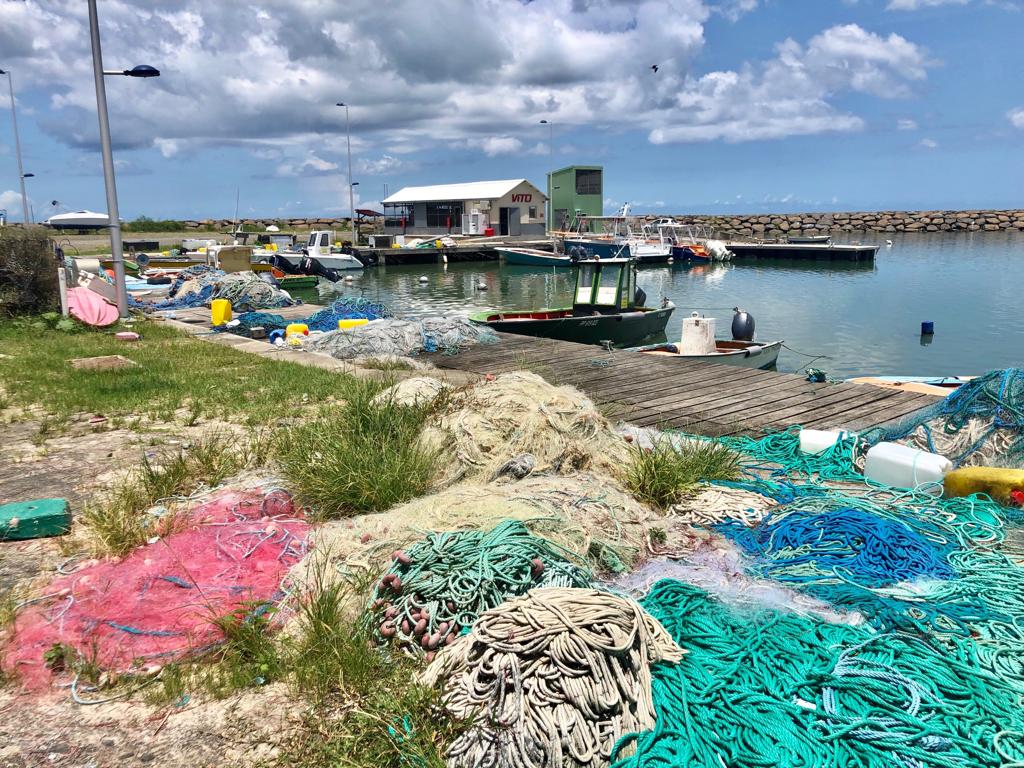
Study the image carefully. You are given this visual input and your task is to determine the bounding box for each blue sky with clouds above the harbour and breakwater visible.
[0,0,1024,221]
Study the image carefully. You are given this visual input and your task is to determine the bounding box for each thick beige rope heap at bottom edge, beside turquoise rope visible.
[422,588,684,768]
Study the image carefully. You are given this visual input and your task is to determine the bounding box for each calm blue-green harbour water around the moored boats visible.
[290,232,1024,378]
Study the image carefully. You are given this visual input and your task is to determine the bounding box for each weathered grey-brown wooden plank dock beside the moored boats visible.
[427,334,936,436]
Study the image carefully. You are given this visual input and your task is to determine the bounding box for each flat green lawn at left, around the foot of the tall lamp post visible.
[0,319,349,424]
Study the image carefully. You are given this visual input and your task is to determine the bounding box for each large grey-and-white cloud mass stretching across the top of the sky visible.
[0,0,931,167]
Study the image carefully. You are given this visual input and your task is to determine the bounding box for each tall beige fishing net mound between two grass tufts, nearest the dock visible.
[423,372,627,482]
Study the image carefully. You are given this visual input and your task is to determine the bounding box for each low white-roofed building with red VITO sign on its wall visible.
[383,178,547,236]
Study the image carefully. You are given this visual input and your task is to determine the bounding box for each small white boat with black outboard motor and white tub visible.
[632,309,783,369]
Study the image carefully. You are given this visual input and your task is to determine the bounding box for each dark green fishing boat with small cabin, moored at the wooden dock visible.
[469,259,676,346]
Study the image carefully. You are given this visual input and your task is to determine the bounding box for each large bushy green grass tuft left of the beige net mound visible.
[278,380,438,519]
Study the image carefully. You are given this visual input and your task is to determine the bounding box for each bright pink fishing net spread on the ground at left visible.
[3,489,309,688]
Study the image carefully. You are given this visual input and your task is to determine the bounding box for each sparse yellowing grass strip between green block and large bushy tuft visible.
[80,431,269,555]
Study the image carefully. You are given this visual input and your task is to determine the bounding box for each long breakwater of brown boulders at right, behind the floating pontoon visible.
[678,210,1024,238]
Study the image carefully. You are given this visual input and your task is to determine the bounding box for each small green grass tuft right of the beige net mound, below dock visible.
[623,438,739,509]
